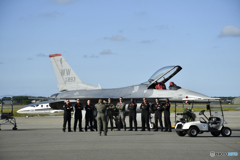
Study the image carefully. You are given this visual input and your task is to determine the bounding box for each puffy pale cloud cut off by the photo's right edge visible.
[219,26,240,37]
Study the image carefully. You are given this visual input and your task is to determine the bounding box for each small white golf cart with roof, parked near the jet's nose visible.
[175,99,232,137]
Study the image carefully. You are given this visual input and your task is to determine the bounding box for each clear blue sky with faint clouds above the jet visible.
[0,0,240,97]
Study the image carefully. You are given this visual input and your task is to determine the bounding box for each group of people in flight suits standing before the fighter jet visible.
[63,97,172,136]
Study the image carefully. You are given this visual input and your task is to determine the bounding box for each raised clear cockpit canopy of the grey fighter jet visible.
[148,65,182,87]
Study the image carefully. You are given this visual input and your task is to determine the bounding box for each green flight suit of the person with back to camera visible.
[95,103,107,135]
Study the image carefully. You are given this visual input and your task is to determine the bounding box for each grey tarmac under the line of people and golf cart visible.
[0,111,240,160]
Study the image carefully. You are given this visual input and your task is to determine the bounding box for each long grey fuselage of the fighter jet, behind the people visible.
[54,84,210,102]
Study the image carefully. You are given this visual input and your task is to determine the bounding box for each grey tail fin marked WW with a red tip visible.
[49,54,100,91]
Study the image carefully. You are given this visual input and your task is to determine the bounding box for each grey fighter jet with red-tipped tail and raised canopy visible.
[40,54,214,110]
